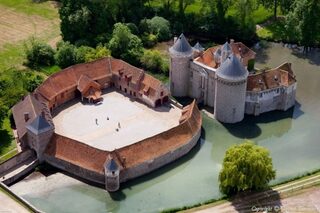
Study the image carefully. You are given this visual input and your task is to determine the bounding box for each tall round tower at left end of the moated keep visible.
[169,34,193,97]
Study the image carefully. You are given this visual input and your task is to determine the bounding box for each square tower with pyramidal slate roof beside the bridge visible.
[26,115,54,162]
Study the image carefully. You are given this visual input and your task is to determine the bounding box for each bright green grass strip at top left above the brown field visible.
[0,0,59,20]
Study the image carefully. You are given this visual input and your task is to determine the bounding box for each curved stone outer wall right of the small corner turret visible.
[120,128,201,183]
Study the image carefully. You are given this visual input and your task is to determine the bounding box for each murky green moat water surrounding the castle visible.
[11,43,320,213]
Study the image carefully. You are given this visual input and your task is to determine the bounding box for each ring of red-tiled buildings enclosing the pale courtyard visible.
[10,57,202,191]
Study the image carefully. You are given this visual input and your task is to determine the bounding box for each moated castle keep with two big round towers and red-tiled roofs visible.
[169,34,297,123]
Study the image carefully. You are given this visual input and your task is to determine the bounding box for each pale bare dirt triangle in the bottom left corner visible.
[0,190,29,213]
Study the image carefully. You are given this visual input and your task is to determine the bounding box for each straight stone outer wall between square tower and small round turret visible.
[44,155,105,184]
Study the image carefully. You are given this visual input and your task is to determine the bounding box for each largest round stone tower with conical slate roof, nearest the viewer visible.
[214,54,249,123]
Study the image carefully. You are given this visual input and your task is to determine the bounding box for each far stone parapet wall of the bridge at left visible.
[0,149,35,177]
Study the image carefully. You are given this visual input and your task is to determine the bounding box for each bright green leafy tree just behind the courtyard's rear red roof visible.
[108,23,143,65]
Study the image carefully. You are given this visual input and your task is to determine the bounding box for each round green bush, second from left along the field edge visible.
[55,42,77,68]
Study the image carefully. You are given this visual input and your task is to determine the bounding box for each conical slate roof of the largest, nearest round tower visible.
[217,54,249,80]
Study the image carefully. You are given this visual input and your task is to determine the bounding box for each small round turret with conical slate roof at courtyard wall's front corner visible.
[104,159,120,192]
